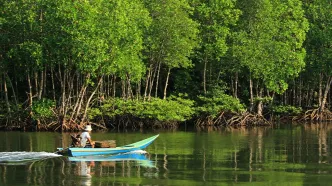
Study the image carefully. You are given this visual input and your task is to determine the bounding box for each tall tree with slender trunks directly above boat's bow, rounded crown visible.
[145,0,198,99]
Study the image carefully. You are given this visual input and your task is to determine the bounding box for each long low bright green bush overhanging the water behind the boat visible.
[89,95,194,122]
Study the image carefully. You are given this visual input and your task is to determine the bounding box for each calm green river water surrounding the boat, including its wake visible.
[0,124,332,186]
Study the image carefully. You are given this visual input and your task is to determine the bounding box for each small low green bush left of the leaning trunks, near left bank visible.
[31,99,55,119]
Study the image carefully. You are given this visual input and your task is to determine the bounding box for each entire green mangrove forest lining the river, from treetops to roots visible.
[0,0,332,131]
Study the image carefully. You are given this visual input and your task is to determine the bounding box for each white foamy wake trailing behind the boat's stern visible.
[0,151,61,165]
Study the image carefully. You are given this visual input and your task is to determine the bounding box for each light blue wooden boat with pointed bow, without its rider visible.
[58,134,159,156]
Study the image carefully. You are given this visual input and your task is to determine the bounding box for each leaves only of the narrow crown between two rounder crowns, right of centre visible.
[191,0,240,60]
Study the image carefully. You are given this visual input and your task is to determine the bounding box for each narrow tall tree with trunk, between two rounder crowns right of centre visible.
[191,0,240,94]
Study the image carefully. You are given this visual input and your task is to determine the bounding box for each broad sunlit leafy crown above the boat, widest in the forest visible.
[51,0,150,80]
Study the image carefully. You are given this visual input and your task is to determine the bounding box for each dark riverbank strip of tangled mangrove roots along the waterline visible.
[0,107,331,132]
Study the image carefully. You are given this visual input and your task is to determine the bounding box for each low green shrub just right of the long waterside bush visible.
[197,89,245,117]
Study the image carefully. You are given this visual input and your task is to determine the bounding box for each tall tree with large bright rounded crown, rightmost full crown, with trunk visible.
[233,0,308,115]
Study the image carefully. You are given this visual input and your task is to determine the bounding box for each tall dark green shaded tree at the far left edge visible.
[0,1,45,123]
